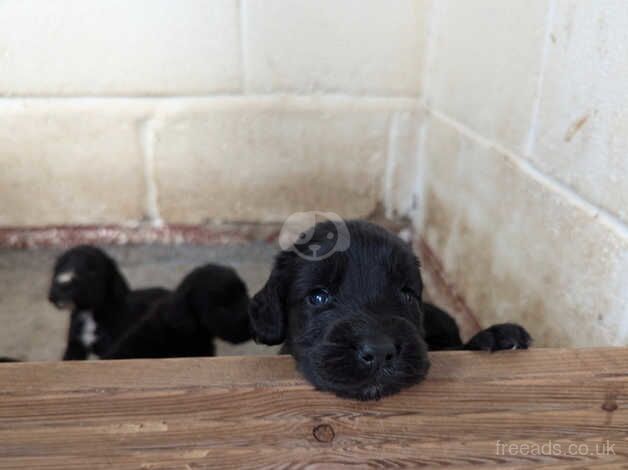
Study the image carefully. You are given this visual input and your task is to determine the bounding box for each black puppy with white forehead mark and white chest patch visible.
[48,245,168,360]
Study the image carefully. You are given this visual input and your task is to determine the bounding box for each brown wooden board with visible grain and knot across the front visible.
[0,348,628,470]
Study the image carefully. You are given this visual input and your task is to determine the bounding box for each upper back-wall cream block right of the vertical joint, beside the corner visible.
[243,0,428,96]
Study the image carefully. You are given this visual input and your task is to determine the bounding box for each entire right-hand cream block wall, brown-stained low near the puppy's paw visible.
[414,0,628,346]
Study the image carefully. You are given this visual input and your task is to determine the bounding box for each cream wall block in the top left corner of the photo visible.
[0,0,241,96]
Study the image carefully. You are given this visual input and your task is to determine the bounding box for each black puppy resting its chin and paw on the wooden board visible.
[249,221,530,400]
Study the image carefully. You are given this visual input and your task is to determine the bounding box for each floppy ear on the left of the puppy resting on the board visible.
[249,251,294,345]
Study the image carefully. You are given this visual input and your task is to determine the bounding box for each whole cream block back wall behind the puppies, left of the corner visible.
[0,0,427,225]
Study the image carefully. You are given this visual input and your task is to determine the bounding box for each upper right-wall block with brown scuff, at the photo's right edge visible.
[530,1,628,222]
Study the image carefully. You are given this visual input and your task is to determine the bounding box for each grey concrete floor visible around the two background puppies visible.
[0,242,277,361]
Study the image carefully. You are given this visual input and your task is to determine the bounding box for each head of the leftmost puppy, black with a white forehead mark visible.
[48,245,129,310]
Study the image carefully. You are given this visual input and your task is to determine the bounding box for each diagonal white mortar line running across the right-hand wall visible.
[425,106,628,240]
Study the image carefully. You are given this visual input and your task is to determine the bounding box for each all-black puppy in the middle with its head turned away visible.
[104,264,251,359]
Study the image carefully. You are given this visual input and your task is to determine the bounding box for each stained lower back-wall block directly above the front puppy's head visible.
[155,98,414,223]
